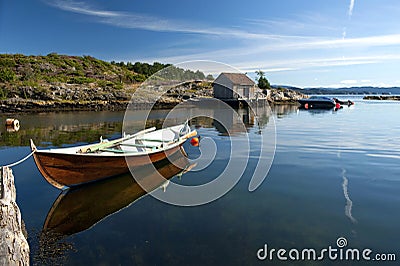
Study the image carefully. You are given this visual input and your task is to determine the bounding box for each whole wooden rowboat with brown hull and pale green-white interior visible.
[31,123,197,189]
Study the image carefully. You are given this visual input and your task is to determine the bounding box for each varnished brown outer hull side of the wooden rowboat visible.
[33,145,181,189]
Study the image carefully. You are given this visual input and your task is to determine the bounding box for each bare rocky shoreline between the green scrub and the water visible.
[0,81,307,113]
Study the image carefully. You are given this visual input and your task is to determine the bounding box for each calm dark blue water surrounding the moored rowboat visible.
[0,97,400,265]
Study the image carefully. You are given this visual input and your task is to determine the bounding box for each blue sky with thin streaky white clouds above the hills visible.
[0,0,400,87]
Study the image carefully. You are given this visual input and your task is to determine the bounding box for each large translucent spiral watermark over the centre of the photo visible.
[122,61,276,206]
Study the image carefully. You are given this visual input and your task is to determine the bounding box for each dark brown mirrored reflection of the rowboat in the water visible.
[43,149,189,235]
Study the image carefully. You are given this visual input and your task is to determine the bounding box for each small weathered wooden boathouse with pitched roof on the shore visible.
[213,73,262,101]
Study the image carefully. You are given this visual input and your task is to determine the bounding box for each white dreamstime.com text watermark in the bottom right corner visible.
[257,237,396,261]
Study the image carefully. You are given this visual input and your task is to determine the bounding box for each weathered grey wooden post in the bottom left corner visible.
[0,167,29,265]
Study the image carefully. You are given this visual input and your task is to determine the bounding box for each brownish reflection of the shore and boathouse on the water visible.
[0,101,298,147]
